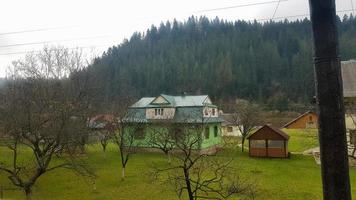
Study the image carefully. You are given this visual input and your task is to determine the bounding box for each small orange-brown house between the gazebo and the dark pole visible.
[283,111,318,129]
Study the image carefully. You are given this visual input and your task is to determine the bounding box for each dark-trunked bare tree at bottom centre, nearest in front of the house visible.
[152,124,255,200]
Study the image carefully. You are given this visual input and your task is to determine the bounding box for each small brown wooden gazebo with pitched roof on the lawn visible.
[247,125,289,158]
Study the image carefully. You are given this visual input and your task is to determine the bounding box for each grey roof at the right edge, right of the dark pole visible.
[341,60,356,97]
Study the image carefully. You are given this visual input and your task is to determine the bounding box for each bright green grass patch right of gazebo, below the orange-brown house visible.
[283,129,319,152]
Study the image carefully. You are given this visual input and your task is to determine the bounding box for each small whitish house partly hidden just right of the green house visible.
[220,113,241,137]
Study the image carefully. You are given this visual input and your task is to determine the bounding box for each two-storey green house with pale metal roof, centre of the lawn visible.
[123,94,222,154]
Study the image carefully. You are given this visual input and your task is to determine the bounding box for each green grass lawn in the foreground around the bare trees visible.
[0,140,356,200]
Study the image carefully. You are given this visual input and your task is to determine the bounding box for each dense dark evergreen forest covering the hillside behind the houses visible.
[87,16,356,110]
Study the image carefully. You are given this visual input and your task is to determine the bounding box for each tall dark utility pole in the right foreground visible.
[309,0,351,200]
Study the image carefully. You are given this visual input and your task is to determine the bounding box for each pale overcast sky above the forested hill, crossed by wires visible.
[0,0,356,77]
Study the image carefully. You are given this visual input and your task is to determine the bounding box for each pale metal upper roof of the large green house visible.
[131,94,216,108]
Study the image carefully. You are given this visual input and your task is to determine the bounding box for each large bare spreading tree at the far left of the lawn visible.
[0,48,94,199]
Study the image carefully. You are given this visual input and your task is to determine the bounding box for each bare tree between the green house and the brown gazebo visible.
[229,99,261,152]
